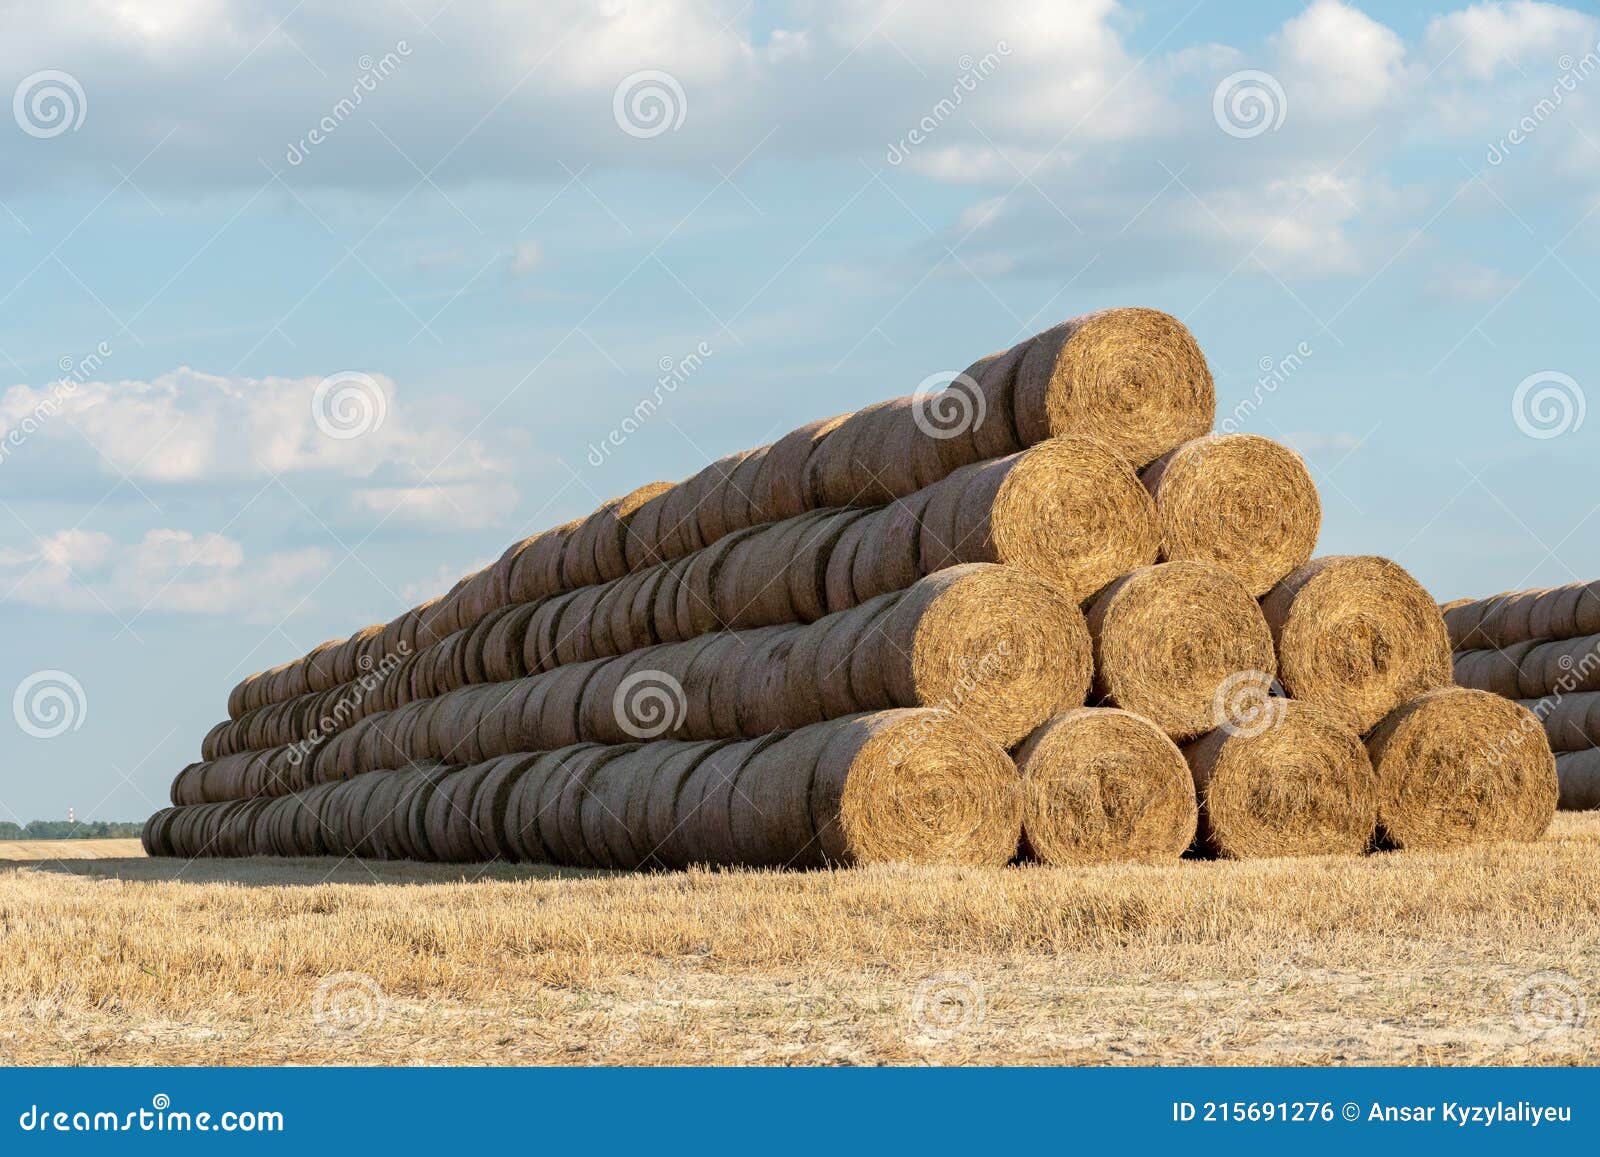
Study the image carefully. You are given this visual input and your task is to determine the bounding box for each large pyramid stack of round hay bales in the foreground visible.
[146,309,1554,869]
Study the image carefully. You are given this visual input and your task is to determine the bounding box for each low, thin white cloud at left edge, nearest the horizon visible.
[0,528,328,618]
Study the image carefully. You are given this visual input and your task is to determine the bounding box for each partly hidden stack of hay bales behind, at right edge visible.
[1443,583,1600,811]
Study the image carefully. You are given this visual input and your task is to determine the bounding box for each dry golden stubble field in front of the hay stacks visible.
[0,813,1600,1064]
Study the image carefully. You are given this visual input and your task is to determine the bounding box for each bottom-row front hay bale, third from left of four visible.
[1184,699,1378,859]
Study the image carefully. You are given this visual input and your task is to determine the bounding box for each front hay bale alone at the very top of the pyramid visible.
[1011,309,1216,469]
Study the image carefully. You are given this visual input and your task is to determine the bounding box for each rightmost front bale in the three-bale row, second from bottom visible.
[1261,555,1451,735]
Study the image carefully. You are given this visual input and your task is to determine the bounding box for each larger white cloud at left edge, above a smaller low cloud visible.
[0,366,518,528]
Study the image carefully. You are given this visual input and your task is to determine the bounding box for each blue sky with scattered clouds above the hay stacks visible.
[0,0,1600,819]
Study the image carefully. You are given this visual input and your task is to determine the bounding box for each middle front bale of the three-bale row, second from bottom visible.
[1088,562,1277,743]
